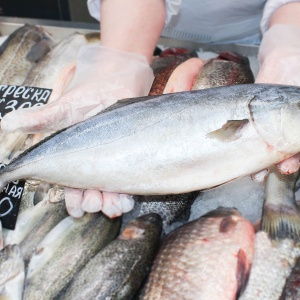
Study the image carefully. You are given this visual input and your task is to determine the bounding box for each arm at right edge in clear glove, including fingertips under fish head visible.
[255,1,300,174]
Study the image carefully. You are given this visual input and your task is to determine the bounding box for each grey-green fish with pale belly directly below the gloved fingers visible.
[23,213,120,300]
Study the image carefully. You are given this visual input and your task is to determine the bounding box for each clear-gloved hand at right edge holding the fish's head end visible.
[255,24,300,174]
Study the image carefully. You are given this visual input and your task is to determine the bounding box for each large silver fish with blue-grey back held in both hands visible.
[0,84,300,195]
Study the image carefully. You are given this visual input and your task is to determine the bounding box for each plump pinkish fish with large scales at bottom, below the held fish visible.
[139,208,255,300]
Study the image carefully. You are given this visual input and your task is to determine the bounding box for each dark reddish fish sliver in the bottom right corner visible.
[280,258,300,300]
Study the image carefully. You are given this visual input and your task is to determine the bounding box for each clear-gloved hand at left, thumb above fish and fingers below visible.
[1,45,154,217]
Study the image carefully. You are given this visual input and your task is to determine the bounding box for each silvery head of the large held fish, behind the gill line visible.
[249,85,300,153]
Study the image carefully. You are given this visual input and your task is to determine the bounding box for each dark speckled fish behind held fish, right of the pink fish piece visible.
[192,51,254,90]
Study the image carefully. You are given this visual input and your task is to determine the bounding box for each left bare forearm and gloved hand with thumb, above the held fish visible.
[1,0,165,133]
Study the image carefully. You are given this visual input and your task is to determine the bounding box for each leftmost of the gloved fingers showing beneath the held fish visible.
[65,187,84,218]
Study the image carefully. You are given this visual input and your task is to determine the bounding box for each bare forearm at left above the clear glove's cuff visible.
[100,0,165,63]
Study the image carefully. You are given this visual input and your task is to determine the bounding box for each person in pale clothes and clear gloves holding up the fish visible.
[2,0,300,217]
